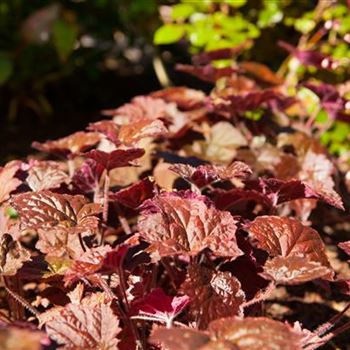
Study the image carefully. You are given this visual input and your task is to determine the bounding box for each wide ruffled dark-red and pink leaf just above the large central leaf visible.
[170,162,252,188]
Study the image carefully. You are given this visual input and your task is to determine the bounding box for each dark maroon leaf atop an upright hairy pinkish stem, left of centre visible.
[85,148,145,171]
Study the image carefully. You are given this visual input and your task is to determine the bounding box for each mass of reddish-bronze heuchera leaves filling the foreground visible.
[0,6,350,350]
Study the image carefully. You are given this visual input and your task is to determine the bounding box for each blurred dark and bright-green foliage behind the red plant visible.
[0,0,350,159]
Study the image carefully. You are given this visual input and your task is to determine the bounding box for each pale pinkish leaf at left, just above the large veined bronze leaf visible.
[26,161,69,191]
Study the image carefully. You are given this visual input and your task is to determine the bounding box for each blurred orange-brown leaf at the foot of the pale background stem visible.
[151,86,205,110]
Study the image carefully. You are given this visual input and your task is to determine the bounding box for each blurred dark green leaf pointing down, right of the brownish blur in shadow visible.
[52,20,78,61]
